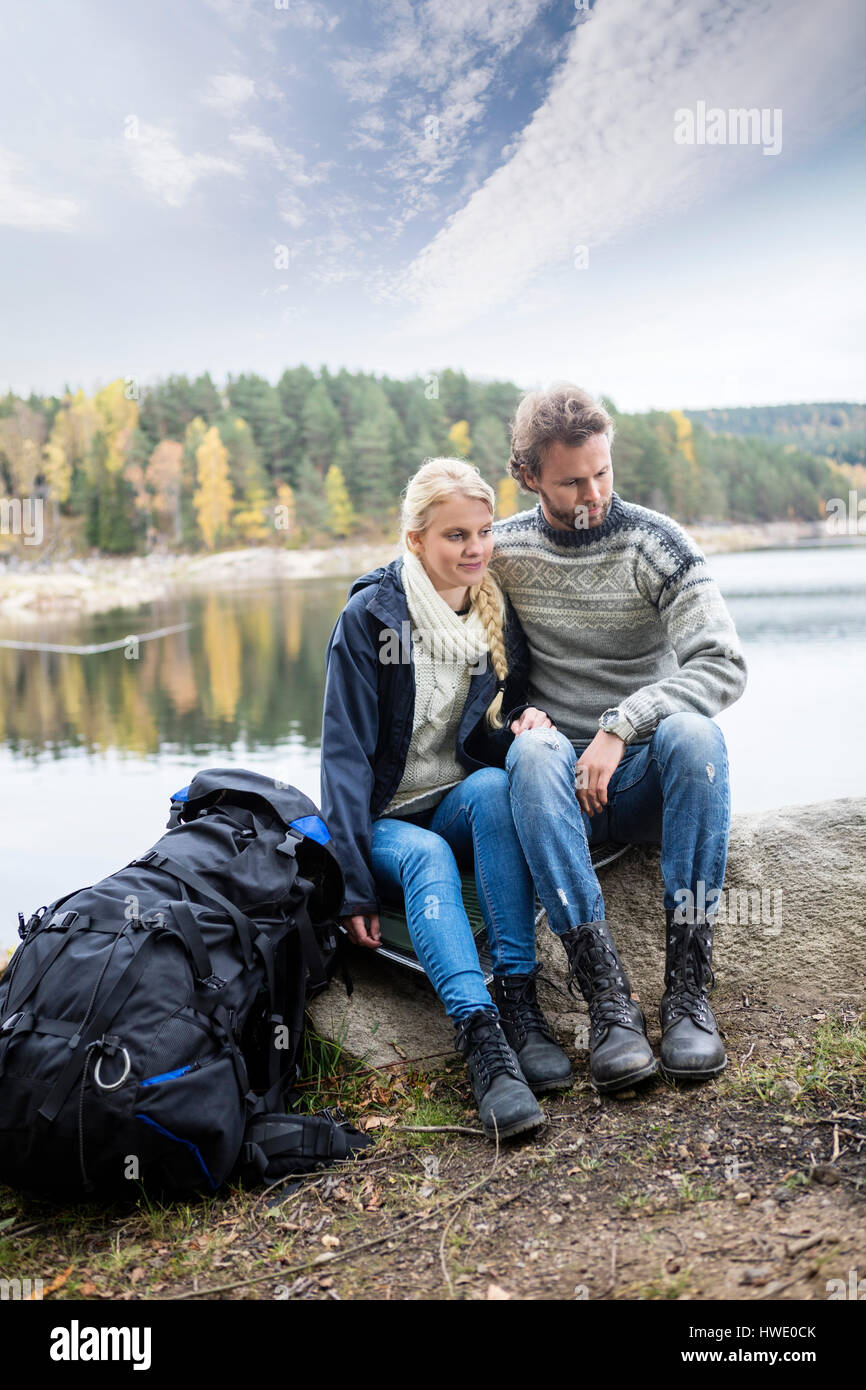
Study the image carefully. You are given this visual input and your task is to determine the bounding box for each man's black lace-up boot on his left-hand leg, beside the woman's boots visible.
[562,922,659,1091]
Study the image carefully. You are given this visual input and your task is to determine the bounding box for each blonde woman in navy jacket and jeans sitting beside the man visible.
[321,459,571,1138]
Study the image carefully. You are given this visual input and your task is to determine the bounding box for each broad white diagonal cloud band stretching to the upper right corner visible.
[399,0,866,328]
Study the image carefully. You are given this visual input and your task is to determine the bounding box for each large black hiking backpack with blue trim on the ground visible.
[0,769,367,1198]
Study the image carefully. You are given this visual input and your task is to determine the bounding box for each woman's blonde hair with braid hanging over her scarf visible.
[400,459,509,728]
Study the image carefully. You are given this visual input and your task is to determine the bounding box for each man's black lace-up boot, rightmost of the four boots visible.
[659,908,727,1081]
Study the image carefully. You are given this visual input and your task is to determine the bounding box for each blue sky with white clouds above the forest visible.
[0,0,866,410]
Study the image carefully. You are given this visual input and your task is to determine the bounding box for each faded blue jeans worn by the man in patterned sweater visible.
[506,713,731,935]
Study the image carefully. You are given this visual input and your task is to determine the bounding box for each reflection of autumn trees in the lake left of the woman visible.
[0,580,346,758]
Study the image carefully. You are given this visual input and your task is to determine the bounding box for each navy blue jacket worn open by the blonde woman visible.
[321,559,530,916]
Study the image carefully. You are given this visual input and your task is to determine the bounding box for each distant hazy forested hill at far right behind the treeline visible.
[685,400,866,464]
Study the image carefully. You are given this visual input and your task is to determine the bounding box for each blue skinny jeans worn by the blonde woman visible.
[371,767,535,1022]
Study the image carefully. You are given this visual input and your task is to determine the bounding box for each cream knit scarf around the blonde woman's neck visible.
[402,550,489,724]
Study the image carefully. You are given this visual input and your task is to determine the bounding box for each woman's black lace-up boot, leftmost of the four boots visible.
[455,1009,546,1140]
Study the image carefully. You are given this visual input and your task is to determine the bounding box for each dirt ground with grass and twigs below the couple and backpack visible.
[0,997,866,1301]
